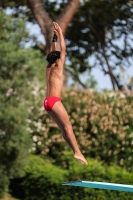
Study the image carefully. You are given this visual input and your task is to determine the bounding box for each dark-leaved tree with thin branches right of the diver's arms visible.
[66,0,133,90]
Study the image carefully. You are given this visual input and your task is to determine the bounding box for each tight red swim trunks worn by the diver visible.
[44,96,61,111]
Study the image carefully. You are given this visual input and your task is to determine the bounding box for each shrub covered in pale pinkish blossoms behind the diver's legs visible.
[29,89,133,171]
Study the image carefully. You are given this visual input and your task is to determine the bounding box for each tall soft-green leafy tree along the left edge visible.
[0,11,43,196]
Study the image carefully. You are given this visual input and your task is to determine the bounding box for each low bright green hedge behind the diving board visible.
[10,156,133,200]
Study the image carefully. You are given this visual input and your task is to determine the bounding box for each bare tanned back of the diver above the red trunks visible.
[46,62,63,97]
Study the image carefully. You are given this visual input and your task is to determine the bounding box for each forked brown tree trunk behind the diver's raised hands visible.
[27,0,80,54]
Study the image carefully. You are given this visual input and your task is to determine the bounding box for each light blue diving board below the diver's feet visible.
[62,181,133,192]
